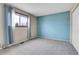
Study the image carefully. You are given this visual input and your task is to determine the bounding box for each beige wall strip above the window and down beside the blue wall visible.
[15,9,37,39]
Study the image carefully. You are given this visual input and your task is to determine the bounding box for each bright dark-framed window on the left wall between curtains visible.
[13,13,28,27]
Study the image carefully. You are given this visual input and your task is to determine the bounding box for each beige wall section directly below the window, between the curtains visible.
[13,27,28,43]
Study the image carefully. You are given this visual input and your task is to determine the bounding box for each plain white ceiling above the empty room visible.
[10,3,74,16]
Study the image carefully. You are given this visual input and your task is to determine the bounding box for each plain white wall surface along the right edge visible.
[71,6,79,53]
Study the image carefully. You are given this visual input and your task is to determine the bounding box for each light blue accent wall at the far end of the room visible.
[37,11,70,41]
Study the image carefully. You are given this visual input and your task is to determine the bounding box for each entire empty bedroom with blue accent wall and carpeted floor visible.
[0,3,79,55]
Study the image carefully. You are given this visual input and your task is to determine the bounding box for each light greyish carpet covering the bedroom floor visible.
[0,38,78,55]
